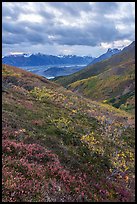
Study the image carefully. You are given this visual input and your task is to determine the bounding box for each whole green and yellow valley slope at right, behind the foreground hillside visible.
[54,42,135,113]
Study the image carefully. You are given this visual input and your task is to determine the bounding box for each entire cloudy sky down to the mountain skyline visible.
[2,2,135,57]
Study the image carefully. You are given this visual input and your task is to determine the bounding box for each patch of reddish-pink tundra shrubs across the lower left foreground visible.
[2,128,133,202]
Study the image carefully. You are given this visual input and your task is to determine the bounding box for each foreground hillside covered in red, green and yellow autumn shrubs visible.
[2,65,135,202]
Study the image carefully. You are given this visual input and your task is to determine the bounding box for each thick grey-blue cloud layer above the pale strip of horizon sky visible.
[2,2,134,55]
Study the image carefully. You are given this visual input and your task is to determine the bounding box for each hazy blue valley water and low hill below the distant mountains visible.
[20,64,87,79]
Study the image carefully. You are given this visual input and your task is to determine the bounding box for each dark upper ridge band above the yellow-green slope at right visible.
[53,42,135,87]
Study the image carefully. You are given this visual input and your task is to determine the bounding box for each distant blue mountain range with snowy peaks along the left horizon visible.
[2,53,94,67]
